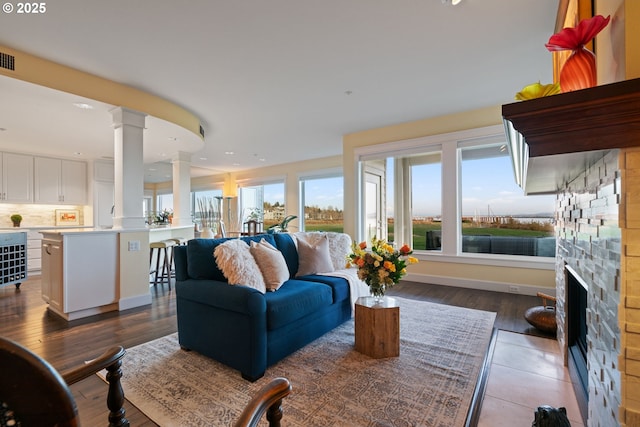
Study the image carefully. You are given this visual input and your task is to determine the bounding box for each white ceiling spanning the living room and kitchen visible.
[0,0,558,181]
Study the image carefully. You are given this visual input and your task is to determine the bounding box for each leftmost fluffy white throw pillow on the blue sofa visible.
[213,239,266,294]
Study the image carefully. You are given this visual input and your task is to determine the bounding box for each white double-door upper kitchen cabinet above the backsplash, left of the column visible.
[34,157,87,205]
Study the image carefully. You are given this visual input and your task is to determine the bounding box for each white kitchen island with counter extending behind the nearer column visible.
[39,225,194,320]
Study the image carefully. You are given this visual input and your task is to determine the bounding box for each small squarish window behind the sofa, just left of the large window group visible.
[299,176,344,232]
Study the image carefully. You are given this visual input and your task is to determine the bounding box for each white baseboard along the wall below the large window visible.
[404,273,556,296]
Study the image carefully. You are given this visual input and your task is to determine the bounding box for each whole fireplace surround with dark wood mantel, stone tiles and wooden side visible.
[502,79,640,427]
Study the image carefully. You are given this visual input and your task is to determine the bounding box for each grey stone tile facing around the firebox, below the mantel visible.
[556,150,620,426]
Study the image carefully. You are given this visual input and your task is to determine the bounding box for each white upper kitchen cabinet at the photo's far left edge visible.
[0,153,33,203]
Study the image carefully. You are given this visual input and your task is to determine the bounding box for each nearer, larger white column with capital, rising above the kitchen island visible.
[111,107,147,229]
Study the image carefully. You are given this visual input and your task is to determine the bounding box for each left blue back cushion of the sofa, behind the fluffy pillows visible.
[187,234,275,282]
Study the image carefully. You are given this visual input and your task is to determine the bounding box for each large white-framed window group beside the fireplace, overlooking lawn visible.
[359,127,555,257]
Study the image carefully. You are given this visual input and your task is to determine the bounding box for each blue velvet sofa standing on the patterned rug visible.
[174,234,351,381]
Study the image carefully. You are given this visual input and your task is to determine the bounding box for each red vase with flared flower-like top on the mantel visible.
[545,15,611,92]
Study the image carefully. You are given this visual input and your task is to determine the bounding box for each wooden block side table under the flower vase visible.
[355,297,400,359]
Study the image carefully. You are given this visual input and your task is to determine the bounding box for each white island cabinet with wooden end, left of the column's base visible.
[40,229,118,320]
